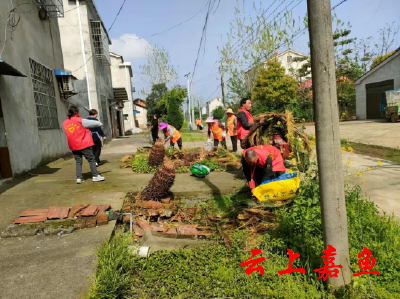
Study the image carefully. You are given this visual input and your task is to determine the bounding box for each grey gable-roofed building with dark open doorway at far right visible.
[355,48,400,119]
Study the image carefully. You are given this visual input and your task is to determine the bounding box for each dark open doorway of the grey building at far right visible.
[365,80,394,119]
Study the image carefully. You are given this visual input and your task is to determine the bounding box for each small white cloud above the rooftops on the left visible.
[110,33,151,62]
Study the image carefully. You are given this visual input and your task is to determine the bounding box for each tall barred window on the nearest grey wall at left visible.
[29,58,59,130]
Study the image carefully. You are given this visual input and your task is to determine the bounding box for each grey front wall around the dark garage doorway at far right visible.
[356,55,400,119]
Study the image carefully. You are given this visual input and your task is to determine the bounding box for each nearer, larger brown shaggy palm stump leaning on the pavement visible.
[139,161,175,201]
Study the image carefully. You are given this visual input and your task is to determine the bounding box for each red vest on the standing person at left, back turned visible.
[63,116,94,151]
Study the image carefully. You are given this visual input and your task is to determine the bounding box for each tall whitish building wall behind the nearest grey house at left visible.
[59,0,112,140]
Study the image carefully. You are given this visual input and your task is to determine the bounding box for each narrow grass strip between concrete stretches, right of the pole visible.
[340,139,400,163]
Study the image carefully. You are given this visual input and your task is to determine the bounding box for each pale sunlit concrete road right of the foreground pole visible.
[305,120,400,218]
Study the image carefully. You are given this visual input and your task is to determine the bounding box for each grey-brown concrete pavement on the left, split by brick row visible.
[0,135,244,299]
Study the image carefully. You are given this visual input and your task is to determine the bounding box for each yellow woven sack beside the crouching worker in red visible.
[253,172,300,201]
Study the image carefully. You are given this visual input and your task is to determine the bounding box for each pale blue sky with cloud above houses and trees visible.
[91,0,400,104]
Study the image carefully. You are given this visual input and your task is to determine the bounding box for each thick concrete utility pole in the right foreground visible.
[307,0,351,289]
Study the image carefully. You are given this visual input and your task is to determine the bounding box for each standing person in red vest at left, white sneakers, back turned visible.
[63,106,104,184]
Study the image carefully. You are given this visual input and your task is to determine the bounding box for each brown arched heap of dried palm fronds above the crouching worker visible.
[243,110,312,152]
